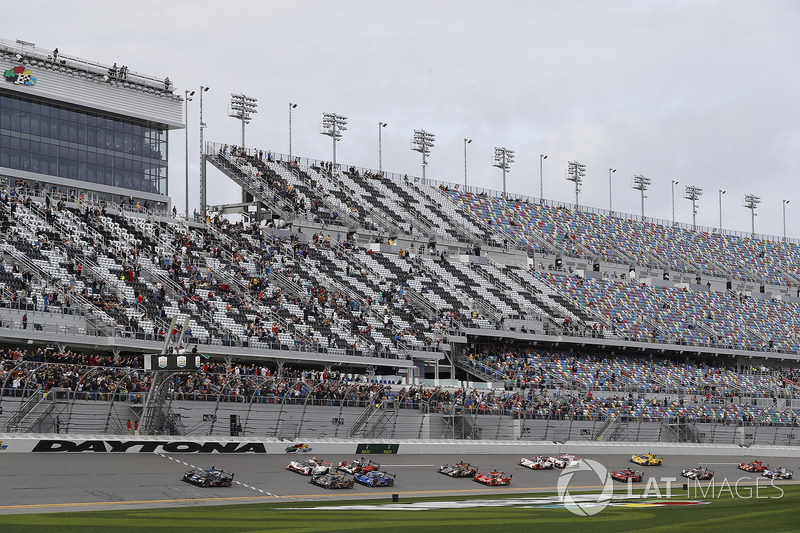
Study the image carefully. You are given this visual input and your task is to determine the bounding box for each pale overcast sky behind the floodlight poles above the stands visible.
[3,0,800,237]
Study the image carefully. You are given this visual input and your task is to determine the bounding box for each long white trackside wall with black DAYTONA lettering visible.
[0,434,800,459]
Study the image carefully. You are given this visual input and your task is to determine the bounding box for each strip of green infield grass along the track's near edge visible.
[0,485,800,533]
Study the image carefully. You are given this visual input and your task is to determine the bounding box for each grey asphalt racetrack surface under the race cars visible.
[0,450,800,514]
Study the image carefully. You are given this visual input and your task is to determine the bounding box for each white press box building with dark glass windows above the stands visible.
[0,39,185,211]
